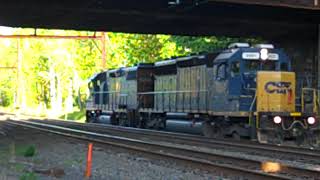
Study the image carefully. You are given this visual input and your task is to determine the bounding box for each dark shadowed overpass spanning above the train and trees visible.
[0,0,320,86]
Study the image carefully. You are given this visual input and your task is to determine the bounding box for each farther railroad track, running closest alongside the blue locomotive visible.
[26,117,320,168]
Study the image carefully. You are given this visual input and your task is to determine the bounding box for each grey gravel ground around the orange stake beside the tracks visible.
[0,121,225,180]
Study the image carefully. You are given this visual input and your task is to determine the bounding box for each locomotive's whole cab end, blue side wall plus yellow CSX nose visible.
[212,44,320,144]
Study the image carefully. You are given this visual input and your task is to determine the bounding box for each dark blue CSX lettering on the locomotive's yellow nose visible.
[264,81,292,94]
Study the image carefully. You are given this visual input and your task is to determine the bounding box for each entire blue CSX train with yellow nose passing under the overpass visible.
[86,43,320,144]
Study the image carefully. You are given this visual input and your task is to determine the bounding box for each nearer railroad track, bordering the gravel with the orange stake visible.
[7,121,320,179]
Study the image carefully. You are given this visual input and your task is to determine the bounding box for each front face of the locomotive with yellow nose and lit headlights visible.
[236,46,319,144]
